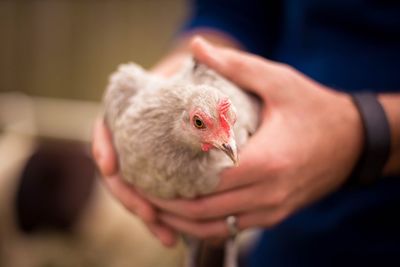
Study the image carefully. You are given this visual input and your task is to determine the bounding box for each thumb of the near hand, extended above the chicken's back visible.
[190,37,278,97]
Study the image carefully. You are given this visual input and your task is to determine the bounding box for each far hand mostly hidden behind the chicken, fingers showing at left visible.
[92,44,203,246]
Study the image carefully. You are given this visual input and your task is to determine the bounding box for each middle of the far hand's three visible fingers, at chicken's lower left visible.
[104,175,156,223]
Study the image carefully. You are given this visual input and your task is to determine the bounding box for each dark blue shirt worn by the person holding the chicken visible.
[185,0,400,267]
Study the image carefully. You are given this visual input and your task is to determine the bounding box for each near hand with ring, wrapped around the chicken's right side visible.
[150,39,363,239]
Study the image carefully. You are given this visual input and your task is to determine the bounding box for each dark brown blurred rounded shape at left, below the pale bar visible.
[15,140,96,233]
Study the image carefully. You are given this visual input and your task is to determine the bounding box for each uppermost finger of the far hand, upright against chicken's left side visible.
[92,119,118,176]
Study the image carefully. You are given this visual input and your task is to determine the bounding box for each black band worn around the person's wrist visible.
[352,93,391,184]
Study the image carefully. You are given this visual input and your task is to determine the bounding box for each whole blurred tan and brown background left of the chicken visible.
[0,0,188,267]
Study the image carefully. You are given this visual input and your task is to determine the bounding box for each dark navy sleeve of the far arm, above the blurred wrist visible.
[183,0,281,56]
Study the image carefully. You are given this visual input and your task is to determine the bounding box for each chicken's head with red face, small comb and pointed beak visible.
[184,87,238,164]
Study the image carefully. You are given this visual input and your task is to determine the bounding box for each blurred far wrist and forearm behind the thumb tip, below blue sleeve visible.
[152,29,241,77]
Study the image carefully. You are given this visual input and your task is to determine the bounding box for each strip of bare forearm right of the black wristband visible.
[379,93,400,175]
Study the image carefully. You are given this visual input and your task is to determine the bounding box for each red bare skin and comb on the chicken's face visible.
[190,99,234,152]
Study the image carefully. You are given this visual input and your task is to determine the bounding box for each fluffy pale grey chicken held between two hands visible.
[104,59,259,267]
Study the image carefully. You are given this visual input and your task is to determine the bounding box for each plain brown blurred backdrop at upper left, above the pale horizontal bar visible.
[0,0,186,100]
